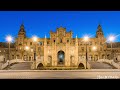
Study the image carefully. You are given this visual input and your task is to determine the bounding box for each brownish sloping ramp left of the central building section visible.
[5,62,32,70]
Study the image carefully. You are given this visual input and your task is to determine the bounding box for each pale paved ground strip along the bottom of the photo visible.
[0,69,120,79]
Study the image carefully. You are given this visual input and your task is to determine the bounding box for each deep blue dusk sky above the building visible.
[0,11,120,42]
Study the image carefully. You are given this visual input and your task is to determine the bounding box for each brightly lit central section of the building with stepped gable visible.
[44,27,78,67]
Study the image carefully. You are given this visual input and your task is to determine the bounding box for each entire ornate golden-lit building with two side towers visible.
[0,24,120,68]
